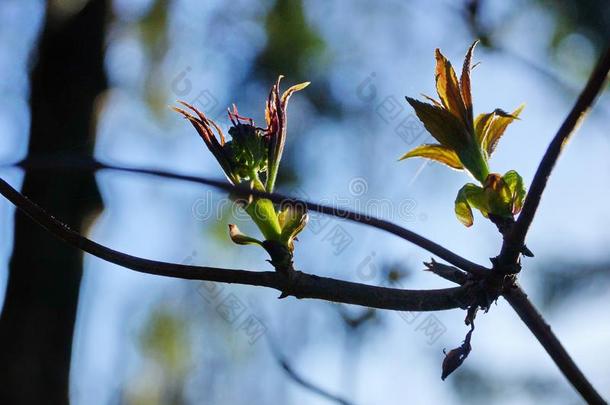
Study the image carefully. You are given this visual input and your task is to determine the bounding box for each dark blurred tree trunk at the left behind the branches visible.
[0,0,107,405]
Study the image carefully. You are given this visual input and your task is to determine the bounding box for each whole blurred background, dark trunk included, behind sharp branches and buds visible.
[0,0,610,405]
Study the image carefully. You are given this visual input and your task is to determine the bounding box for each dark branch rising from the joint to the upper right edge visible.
[499,47,610,265]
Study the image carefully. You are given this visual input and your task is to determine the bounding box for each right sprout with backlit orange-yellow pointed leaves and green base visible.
[399,41,525,230]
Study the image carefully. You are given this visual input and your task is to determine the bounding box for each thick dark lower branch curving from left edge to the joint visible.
[0,175,471,311]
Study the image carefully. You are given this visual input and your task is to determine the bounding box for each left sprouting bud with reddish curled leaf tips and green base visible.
[174,76,309,271]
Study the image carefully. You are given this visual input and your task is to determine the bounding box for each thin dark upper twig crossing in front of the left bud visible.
[9,157,489,276]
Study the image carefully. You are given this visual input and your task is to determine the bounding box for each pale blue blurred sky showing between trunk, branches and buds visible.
[0,0,610,404]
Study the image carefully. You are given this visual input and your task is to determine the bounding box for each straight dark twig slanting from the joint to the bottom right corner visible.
[503,284,606,404]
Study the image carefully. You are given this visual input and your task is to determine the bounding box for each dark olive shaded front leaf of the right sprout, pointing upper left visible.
[407,97,468,150]
